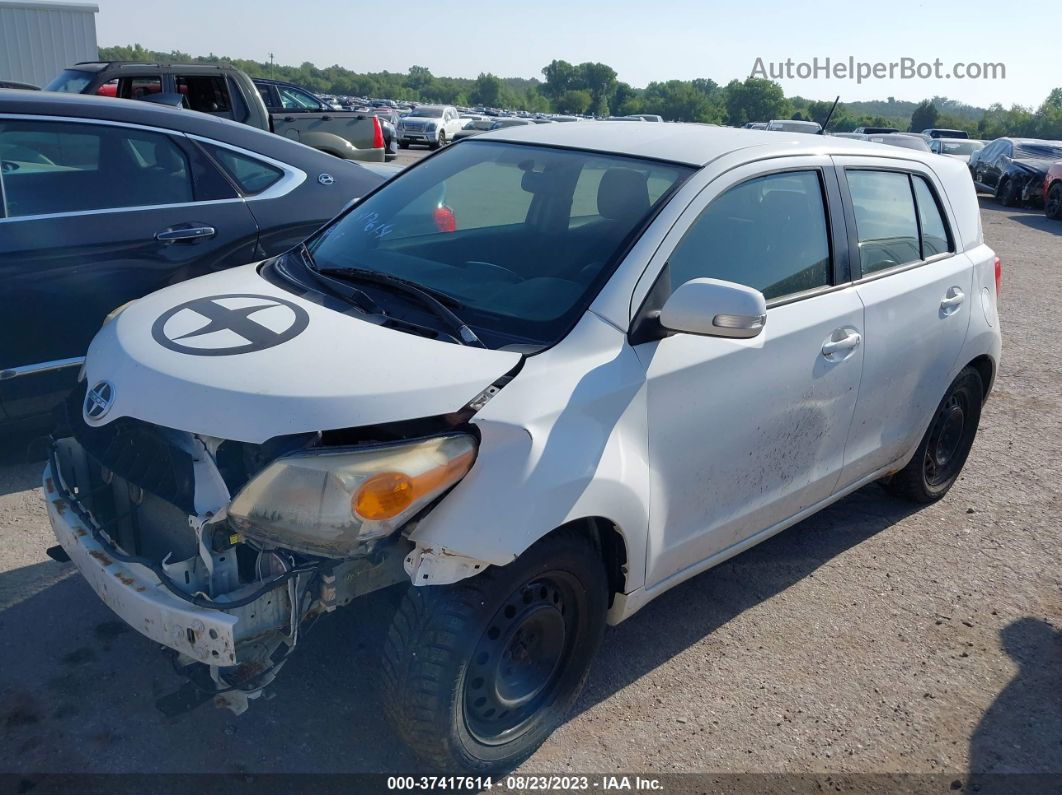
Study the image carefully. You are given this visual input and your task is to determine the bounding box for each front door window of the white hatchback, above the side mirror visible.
[668,171,830,300]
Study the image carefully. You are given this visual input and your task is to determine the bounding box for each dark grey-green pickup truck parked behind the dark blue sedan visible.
[45,61,384,162]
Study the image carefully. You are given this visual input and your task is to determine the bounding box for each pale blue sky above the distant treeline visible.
[96,0,1062,106]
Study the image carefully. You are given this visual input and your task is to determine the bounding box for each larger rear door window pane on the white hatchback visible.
[847,170,922,276]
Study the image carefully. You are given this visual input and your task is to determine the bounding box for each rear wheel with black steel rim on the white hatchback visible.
[881,367,984,503]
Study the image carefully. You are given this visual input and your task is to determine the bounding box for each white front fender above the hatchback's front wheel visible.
[410,314,649,590]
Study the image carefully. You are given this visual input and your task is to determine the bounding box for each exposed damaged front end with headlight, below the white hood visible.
[45,388,477,714]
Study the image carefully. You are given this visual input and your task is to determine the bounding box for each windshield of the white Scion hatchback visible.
[308,139,692,347]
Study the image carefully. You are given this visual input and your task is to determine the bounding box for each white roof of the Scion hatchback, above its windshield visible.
[476,122,928,167]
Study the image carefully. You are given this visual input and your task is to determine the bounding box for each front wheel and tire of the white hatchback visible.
[382,531,609,773]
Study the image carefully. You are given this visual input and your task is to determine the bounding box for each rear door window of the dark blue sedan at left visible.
[0,120,192,217]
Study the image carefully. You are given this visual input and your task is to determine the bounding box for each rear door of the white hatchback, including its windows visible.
[835,157,976,487]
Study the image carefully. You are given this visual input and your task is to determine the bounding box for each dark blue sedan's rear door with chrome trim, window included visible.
[0,116,258,416]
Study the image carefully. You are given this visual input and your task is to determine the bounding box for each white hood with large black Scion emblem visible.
[83,264,520,444]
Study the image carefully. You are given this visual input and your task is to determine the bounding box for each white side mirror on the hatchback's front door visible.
[660,279,767,340]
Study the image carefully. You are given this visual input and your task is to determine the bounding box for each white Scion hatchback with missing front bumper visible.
[45,124,1000,772]
